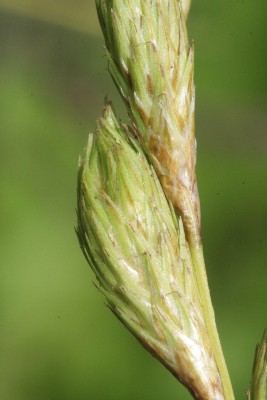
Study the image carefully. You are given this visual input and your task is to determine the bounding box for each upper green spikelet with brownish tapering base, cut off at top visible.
[96,0,200,242]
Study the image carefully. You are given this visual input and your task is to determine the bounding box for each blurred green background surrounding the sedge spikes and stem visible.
[0,0,267,400]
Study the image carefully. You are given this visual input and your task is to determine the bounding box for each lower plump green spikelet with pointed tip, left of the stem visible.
[78,105,226,400]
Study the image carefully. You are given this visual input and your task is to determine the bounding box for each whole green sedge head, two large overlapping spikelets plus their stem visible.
[77,0,251,400]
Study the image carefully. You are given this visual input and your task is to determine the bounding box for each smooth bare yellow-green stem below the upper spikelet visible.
[189,242,235,400]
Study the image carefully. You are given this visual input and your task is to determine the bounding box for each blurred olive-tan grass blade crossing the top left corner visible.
[0,0,100,35]
